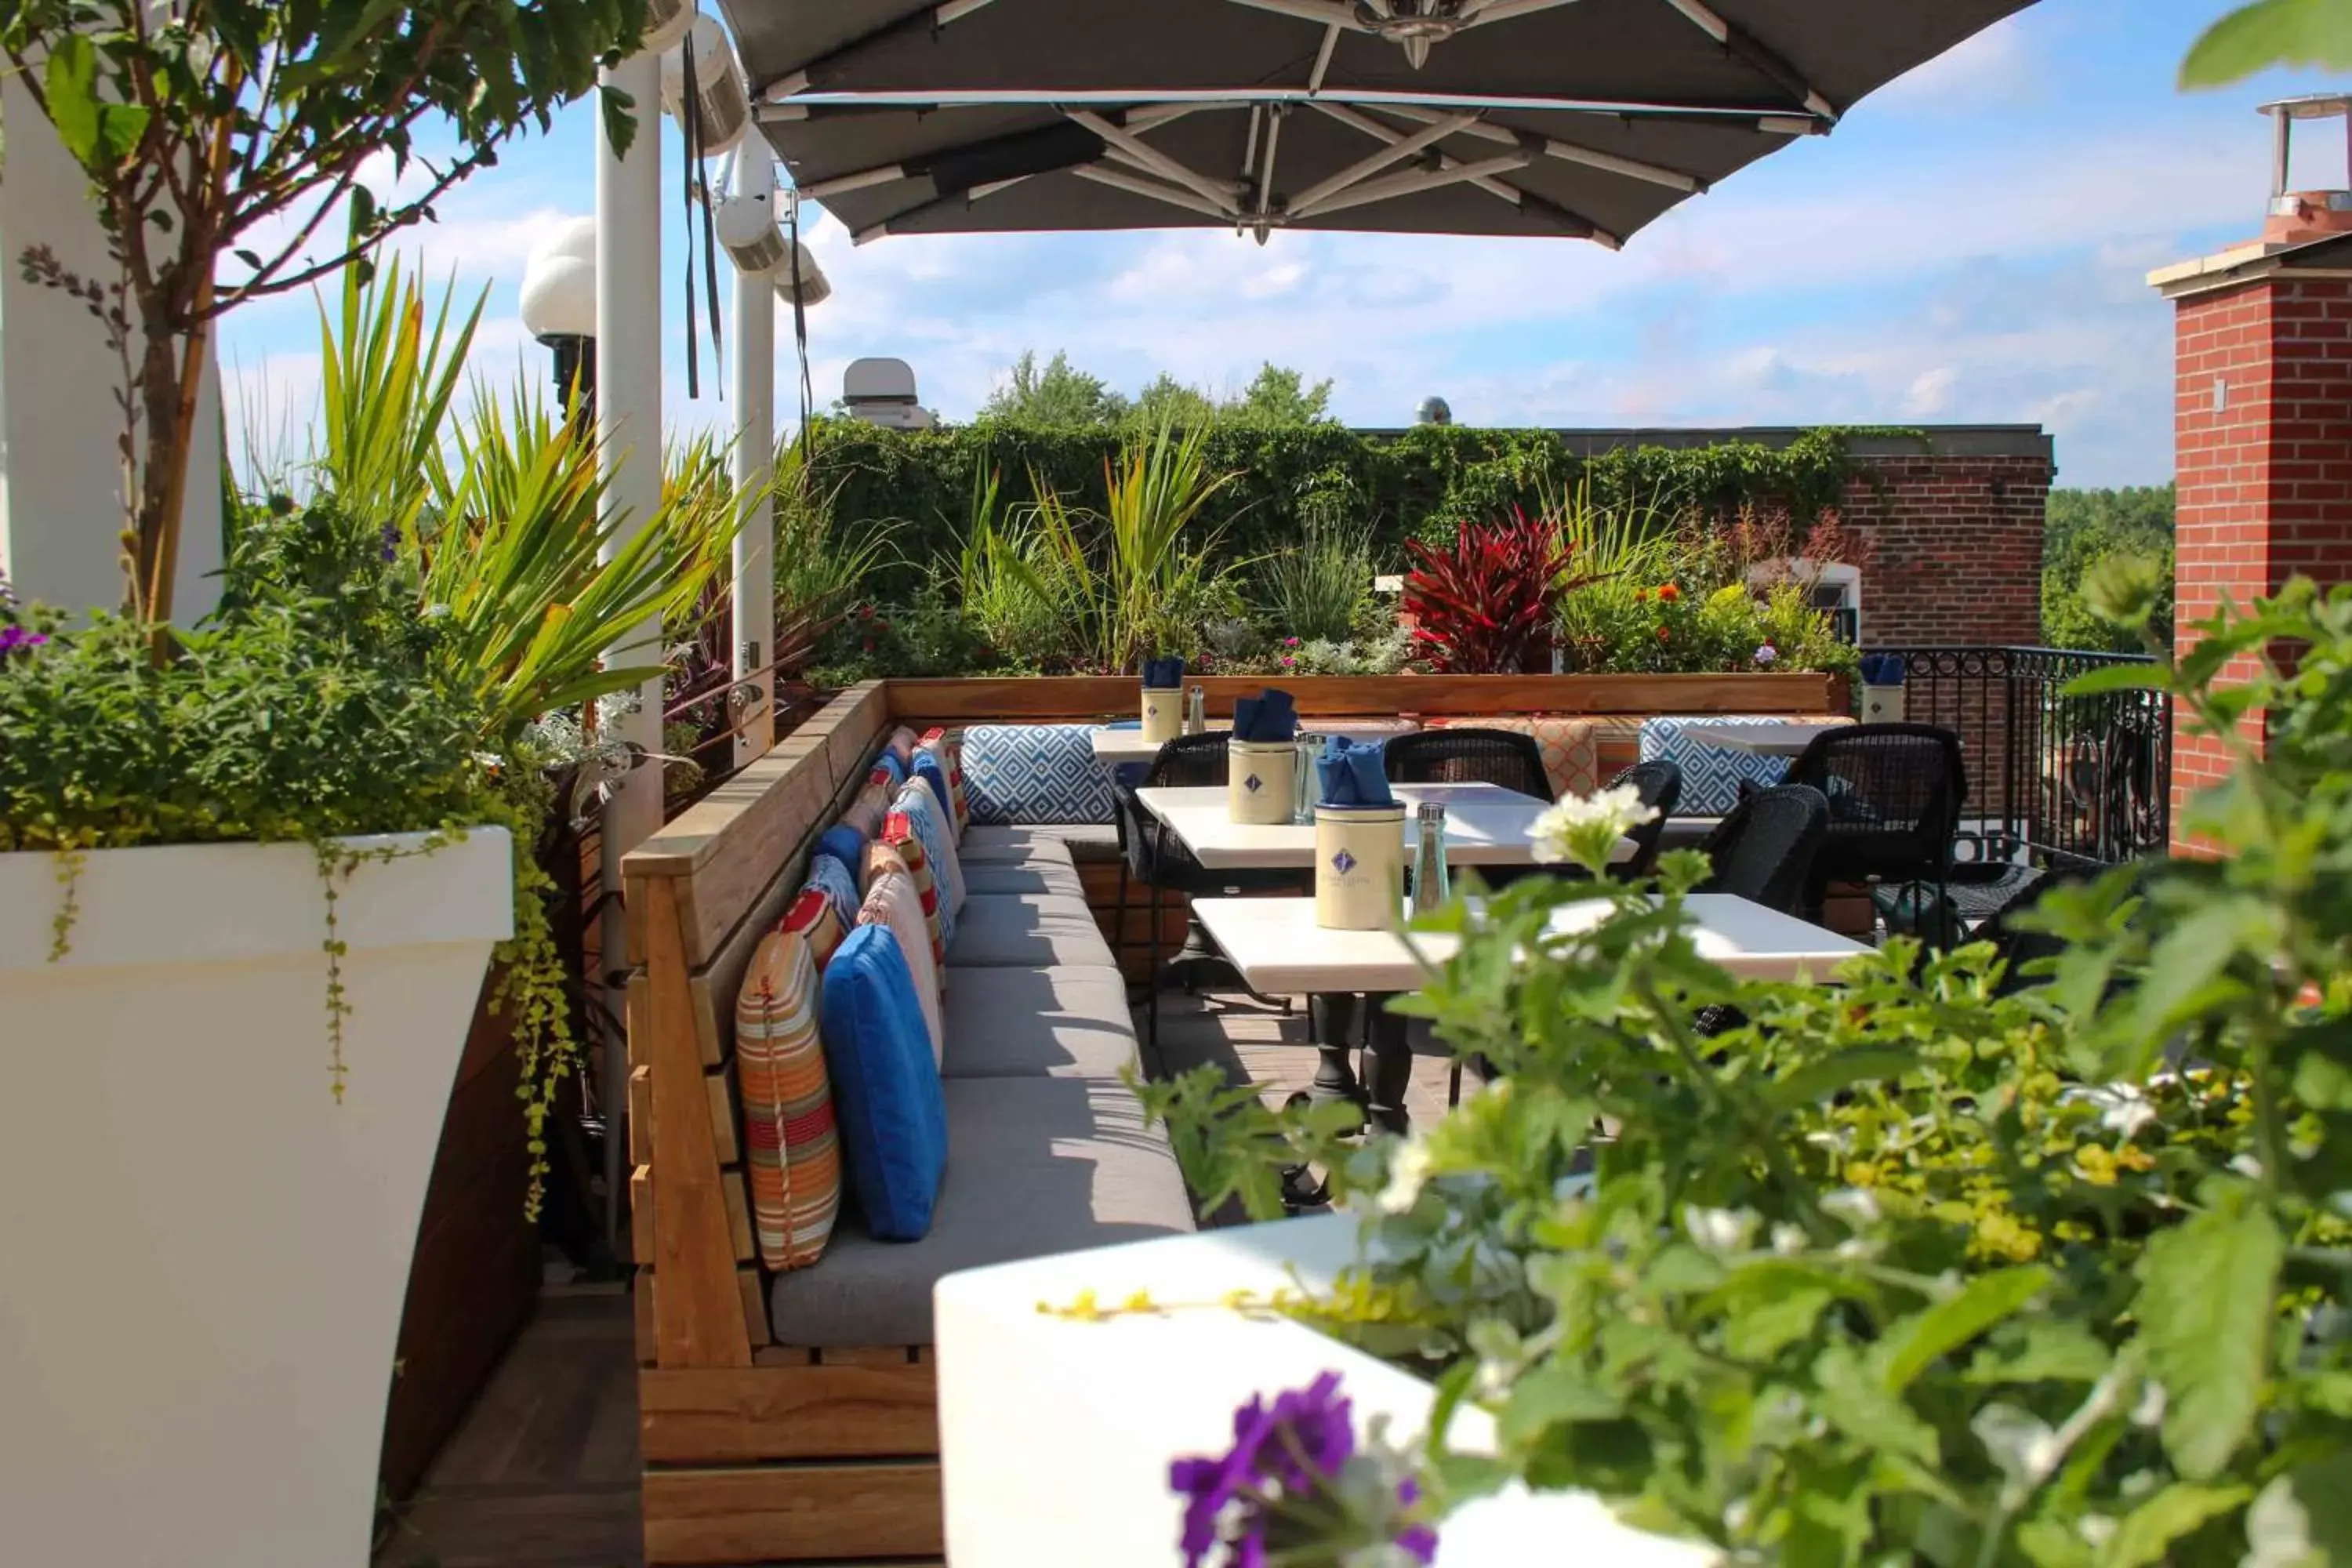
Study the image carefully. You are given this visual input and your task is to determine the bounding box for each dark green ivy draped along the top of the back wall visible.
[811,419,1856,594]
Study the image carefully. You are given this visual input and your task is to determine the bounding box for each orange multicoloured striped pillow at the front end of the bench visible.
[736,931,842,1272]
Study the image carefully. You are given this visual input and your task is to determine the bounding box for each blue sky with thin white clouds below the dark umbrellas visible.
[223,0,2343,485]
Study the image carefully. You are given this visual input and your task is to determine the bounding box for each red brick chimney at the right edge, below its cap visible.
[2173,270,2352,846]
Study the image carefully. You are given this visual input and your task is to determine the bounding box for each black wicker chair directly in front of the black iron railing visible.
[1783,724,1969,931]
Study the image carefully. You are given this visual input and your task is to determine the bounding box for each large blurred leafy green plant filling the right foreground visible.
[1145,580,2352,1568]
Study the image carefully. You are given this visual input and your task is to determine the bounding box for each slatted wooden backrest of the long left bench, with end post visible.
[621,682,889,1368]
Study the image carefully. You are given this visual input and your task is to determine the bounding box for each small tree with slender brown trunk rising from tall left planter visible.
[0,0,644,623]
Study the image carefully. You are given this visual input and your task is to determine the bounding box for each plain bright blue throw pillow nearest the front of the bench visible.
[816,924,948,1241]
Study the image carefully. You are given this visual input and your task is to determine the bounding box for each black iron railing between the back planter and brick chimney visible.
[1875,647,2173,865]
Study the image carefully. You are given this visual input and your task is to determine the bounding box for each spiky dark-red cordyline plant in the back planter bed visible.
[1404,510,1578,675]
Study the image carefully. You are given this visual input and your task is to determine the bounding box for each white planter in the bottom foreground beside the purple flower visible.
[934,1215,1712,1568]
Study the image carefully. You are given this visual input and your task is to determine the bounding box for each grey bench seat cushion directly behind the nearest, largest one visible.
[941,964,1136,1079]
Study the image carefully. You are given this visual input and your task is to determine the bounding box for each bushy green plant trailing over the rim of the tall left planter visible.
[0,508,576,1215]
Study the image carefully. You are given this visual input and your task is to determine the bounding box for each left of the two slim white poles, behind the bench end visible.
[595,52,661,1253]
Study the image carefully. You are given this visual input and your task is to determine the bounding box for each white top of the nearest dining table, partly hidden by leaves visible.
[1192,893,1870,996]
